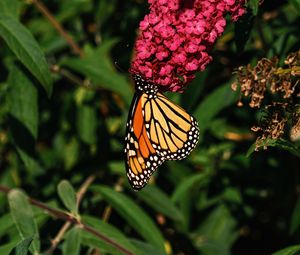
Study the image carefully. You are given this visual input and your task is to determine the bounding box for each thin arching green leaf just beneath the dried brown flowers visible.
[246,138,300,158]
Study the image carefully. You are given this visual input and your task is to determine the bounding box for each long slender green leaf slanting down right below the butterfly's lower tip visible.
[92,185,165,252]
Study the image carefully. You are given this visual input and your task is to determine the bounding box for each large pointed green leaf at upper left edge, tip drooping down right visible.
[0,15,52,96]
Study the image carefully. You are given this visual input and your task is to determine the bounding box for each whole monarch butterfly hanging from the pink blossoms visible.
[125,74,199,190]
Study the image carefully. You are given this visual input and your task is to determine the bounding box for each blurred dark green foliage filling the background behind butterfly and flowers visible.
[0,0,300,255]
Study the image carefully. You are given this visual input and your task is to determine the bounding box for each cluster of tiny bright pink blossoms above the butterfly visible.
[130,0,245,92]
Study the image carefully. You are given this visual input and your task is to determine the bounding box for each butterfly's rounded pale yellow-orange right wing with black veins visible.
[144,92,199,160]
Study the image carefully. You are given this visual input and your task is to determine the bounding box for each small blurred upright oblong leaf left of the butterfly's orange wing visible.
[77,105,98,145]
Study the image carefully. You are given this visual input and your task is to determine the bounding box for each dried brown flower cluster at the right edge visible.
[232,50,300,148]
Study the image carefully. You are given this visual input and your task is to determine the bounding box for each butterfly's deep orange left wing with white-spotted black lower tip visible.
[125,93,163,190]
